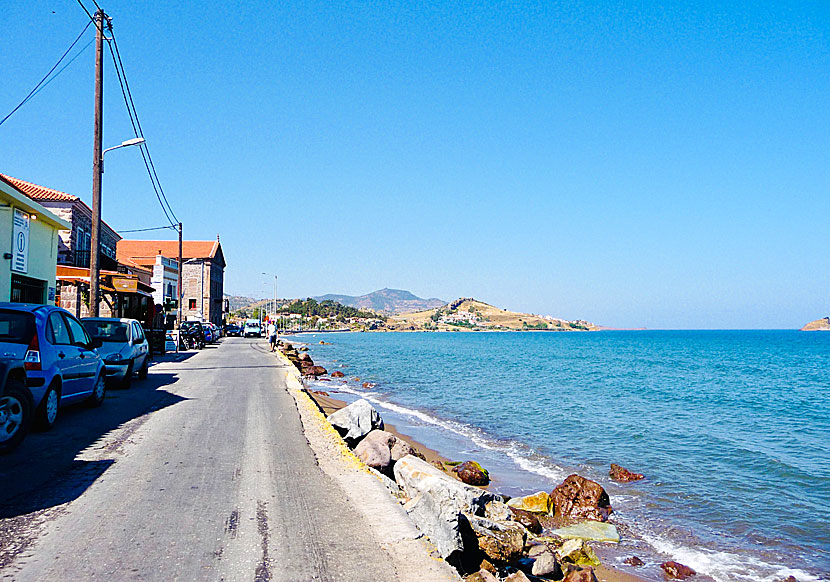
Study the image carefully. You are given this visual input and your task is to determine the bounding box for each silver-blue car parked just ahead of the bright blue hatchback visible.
[81,317,150,388]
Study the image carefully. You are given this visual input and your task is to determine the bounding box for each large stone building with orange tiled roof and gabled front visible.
[116,237,225,325]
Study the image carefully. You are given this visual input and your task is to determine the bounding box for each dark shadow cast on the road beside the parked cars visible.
[0,368,186,529]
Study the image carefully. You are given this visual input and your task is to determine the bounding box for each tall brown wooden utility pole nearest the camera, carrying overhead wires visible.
[89,9,106,317]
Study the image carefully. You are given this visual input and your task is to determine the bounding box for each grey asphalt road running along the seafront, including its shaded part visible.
[0,338,404,582]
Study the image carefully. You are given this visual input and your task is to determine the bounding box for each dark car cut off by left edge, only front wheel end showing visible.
[0,352,35,454]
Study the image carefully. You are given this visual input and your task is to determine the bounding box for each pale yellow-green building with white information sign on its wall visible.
[0,174,70,303]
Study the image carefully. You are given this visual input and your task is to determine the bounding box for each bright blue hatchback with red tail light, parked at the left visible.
[0,303,106,430]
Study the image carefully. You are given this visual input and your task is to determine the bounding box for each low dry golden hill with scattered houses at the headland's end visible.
[386,297,600,331]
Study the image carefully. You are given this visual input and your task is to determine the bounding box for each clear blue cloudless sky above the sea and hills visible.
[0,0,830,328]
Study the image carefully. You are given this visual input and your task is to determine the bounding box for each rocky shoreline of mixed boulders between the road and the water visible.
[281,344,704,582]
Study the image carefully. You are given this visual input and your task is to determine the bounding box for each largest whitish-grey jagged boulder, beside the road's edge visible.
[393,455,501,559]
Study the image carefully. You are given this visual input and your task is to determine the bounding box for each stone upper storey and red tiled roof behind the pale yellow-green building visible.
[0,174,121,271]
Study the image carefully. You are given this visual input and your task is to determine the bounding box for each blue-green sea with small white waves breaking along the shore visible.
[292,330,830,582]
